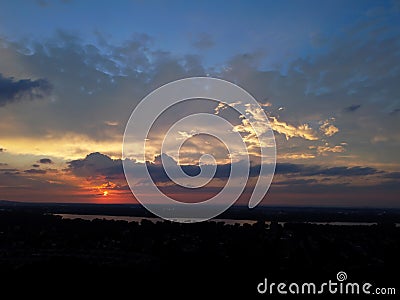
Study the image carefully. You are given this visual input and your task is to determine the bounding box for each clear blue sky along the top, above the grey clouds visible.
[0,0,400,68]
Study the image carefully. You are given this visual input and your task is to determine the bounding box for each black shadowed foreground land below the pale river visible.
[0,203,400,299]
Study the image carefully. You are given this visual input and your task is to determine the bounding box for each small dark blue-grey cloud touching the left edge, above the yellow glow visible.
[0,74,52,106]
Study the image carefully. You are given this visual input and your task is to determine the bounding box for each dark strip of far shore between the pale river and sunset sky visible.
[0,200,400,224]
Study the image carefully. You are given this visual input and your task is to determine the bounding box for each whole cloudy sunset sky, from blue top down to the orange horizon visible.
[0,0,400,208]
